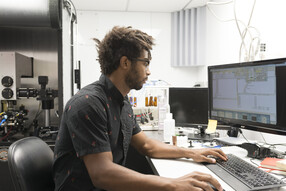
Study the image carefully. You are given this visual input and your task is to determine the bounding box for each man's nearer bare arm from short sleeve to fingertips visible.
[83,152,221,191]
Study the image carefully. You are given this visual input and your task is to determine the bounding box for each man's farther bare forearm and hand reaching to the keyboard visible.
[131,131,227,163]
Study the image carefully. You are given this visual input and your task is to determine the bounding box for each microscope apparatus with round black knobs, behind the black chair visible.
[0,52,58,142]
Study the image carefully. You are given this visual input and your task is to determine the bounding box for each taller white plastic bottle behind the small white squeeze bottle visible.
[158,96,170,130]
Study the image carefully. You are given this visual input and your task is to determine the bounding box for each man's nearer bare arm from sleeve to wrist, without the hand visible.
[83,152,173,191]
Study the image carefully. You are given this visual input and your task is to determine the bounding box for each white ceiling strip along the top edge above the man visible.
[71,0,207,12]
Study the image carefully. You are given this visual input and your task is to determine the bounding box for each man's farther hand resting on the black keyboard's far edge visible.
[190,148,227,163]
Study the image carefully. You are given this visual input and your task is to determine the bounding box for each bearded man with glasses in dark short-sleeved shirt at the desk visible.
[54,27,227,191]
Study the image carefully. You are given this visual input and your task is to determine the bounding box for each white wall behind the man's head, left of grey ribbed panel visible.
[78,11,200,86]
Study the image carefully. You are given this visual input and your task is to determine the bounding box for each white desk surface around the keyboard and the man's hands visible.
[145,131,286,191]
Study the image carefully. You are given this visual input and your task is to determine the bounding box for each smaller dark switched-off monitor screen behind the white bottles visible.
[169,88,208,127]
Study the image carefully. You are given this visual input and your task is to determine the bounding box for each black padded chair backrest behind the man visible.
[8,137,54,191]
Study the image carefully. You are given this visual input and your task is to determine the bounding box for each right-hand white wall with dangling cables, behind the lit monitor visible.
[204,0,286,146]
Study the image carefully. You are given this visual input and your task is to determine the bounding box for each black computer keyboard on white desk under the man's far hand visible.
[204,154,286,191]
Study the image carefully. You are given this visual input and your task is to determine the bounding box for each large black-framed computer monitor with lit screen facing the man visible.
[208,58,286,135]
